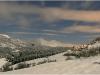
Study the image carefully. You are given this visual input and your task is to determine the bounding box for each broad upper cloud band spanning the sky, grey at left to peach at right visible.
[0,2,100,26]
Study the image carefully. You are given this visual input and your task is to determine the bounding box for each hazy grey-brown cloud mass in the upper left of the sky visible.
[0,2,39,26]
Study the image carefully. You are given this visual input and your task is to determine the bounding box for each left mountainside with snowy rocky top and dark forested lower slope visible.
[0,34,69,64]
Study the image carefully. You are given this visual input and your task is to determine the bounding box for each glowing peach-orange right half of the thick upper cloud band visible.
[46,8,100,22]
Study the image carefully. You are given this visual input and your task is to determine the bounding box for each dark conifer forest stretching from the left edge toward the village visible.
[0,46,69,64]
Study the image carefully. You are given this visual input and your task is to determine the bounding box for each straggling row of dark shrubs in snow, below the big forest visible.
[1,59,57,72]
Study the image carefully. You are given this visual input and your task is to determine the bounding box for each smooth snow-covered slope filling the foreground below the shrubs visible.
[1,53,100,74]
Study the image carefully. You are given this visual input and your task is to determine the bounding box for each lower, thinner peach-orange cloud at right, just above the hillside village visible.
[61,25,100,33]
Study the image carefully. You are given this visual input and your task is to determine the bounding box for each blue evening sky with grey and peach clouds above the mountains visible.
[0,1,100,46]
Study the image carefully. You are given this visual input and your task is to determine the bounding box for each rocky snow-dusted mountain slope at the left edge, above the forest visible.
[0,34,27,49]
